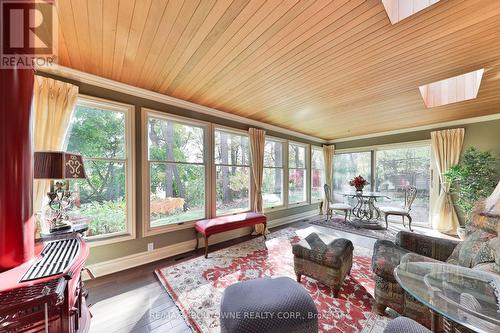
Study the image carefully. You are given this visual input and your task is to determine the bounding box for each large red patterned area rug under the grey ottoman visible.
[156,228,387,333]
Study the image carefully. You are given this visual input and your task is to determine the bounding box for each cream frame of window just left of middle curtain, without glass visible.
[209,124,253,218]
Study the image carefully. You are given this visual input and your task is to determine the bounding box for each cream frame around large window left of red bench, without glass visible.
[141,108,212,237]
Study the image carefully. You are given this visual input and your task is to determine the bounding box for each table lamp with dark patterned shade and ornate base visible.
[33,151,86,232]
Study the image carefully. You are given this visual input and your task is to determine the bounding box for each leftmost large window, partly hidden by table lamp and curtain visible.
[65,98,134,238]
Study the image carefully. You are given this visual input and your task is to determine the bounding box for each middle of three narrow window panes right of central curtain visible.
[288,143,308,204]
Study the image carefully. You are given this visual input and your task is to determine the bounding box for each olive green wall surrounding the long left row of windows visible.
[37,73,320,265]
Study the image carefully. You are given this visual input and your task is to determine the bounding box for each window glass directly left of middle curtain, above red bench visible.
[214,129,250,216]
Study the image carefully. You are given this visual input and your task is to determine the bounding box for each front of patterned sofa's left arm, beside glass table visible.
[372,239,410,282]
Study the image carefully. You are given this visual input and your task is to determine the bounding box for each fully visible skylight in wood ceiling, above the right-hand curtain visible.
[419,68,484,108]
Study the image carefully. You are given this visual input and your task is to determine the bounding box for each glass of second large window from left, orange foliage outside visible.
[147,115,206,228]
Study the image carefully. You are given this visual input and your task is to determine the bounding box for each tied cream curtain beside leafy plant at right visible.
[431,128,465,235]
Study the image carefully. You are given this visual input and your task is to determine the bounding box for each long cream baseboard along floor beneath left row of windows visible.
[83,209,318,280]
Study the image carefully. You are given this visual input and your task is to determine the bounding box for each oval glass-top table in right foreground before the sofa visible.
[394,262,500,333]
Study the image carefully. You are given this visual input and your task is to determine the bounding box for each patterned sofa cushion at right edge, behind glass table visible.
[446,229,496,268]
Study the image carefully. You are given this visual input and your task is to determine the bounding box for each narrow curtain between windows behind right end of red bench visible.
[248,128,268,234]
